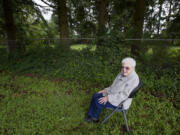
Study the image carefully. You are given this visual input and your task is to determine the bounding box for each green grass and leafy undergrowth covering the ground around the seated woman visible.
[0,45,180,135]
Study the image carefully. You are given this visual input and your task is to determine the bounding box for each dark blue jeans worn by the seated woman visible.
[88,93,116,119]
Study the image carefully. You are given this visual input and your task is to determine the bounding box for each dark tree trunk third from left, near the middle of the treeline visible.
[97,0,106,46]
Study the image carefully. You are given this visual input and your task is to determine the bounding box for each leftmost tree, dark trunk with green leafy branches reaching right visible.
[0,0,48,54]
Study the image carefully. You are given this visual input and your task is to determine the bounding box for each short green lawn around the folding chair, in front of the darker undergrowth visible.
[0,72,179,135]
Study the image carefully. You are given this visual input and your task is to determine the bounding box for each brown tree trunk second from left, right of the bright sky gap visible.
[57,0,69,49]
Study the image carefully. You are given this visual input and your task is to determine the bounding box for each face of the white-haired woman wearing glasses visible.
[121,63,134,76]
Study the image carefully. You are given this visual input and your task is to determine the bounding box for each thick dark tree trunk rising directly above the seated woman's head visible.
[131,0,145,56]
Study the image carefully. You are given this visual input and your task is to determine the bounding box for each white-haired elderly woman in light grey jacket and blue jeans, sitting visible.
[86,57,139,122]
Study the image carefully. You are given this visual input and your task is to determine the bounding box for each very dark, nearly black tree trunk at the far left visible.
[3,0,16,54]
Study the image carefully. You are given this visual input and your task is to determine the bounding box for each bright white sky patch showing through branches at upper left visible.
[33,0,52,20]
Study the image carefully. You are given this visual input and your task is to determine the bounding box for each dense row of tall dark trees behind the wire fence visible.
[0,0,180,54]
